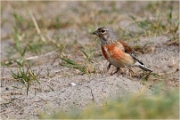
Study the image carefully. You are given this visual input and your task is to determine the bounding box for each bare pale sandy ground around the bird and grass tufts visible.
[0,2,179,119]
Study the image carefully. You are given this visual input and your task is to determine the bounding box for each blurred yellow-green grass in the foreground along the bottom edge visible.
[39,90,179,119]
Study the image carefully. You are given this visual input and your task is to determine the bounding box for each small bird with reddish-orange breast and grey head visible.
[92,27,153,75]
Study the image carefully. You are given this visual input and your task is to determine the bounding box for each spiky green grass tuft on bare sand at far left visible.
[11,63,40,95]
